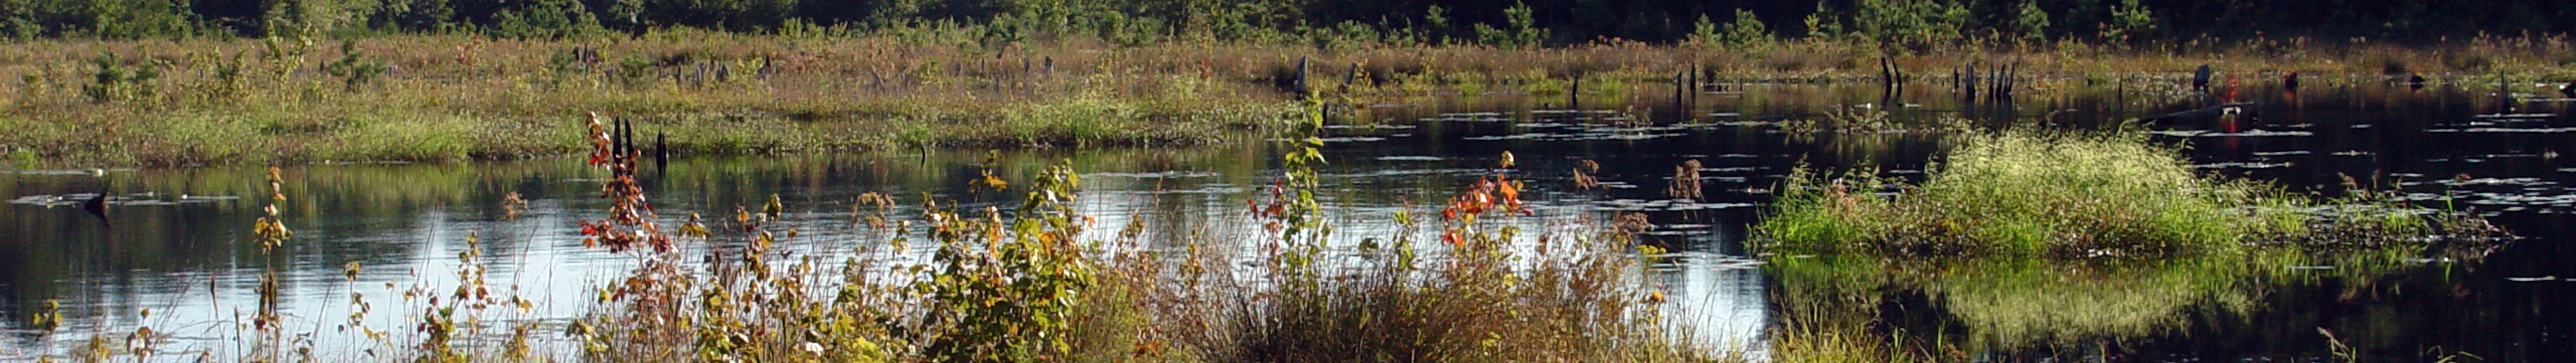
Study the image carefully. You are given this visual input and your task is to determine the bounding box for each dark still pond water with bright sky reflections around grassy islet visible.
[0,85,2576,361]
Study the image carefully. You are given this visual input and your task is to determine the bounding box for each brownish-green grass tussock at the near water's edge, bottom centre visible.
[1203,228,1690,363]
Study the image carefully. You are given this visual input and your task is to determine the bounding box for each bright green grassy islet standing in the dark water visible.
[1757,131,2370,255]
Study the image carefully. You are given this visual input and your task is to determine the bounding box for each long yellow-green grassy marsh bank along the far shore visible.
[0,26,2576,167]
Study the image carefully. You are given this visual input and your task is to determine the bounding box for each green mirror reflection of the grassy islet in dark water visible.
[1765,247,2470,363]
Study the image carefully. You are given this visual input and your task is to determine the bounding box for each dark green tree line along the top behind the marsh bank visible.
[0,0,2576,46]
